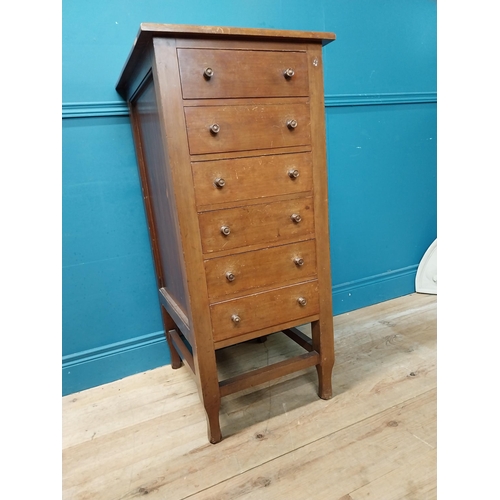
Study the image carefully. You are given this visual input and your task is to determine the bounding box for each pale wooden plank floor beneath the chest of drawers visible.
[63,294,436,500]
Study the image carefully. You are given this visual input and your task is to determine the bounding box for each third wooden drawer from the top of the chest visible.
[191,153,312,207]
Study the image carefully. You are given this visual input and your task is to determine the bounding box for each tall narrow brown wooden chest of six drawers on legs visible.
[117,24,335,443]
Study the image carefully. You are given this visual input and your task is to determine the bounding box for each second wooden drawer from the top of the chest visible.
[184,103,311,155]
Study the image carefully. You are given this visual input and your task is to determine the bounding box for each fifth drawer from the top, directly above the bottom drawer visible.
[205,240,316,302]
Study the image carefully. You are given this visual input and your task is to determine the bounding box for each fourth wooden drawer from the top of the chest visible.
[198,197,314,254]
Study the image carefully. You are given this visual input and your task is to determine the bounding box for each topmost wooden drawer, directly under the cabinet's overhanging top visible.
[177,49,309,99]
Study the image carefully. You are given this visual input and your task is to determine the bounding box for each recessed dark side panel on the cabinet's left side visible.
[133,79,188,314]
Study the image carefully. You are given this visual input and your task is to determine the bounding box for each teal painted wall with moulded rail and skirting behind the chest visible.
[62,0,437,394]
